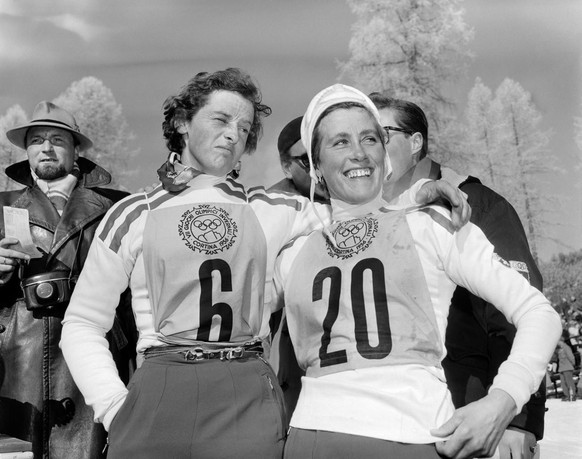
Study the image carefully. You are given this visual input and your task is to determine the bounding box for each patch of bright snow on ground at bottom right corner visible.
[540,398,582,459]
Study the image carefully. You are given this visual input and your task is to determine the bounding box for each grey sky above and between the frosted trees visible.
[0,0,582,259]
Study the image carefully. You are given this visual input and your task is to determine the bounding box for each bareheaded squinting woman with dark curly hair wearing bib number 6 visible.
[61,68,468,459]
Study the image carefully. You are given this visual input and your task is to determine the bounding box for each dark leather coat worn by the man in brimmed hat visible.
[0,158,131,459]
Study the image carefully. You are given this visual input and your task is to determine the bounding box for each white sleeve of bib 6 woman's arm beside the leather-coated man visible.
[60,199,144,430]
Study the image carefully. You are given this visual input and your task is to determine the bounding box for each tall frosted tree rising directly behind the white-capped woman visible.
[340,0,473,162]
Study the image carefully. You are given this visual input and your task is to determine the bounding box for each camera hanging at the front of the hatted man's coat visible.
[20,271,77,311]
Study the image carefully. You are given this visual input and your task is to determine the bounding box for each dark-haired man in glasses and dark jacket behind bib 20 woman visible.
[370,92,546,459]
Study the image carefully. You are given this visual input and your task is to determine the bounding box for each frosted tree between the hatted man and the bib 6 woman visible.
[54,77,138,189]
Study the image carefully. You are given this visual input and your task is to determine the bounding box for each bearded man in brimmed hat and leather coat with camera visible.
[0,102,133,459]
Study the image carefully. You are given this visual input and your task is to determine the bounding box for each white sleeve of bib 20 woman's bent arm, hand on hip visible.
[437,212,561,412]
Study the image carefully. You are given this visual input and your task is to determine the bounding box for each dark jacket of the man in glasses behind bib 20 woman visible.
[443,177,546,440]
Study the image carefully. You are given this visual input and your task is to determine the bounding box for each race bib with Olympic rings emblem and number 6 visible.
[144,203,266,344]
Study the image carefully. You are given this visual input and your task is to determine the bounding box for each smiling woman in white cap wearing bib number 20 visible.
[274,85,561,459]
